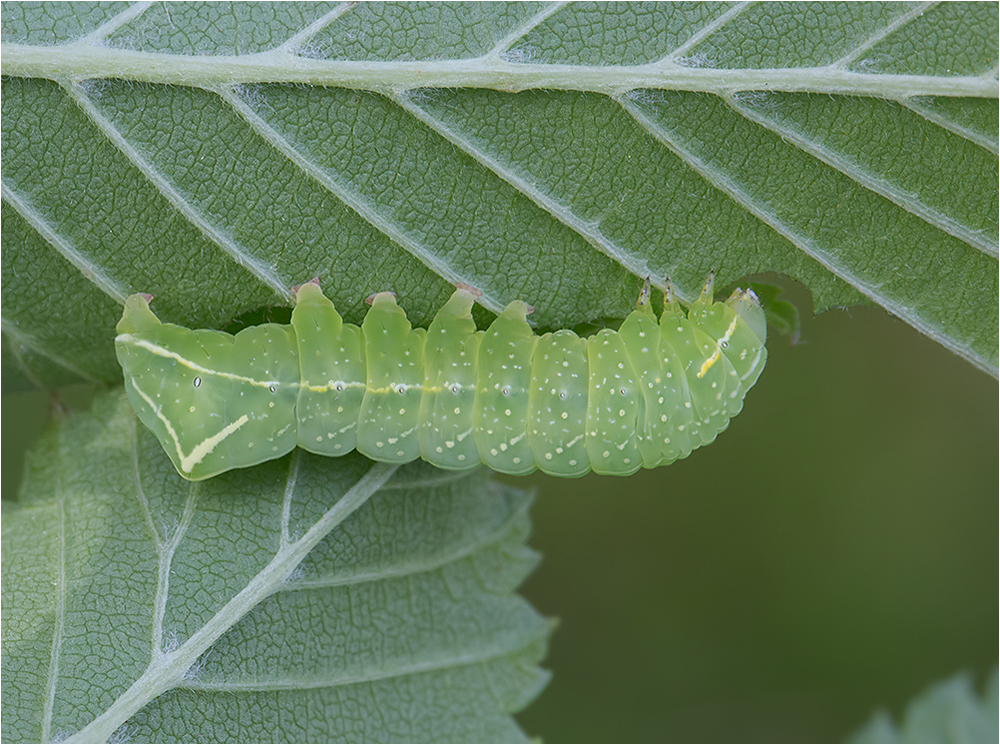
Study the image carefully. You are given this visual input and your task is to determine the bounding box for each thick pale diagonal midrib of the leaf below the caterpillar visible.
[64,463,399,742]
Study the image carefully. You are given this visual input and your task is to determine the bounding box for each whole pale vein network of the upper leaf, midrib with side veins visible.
[0,3,998,384]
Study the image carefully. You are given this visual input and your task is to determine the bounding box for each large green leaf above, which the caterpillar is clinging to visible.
[0,3,998,390]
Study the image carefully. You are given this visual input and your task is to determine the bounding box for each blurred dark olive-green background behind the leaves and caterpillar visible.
[0,284,1000,742]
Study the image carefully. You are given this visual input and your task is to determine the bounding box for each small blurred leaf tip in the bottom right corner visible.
[851,668,1000,743]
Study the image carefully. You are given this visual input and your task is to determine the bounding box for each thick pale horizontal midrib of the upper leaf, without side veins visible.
[0,42,998,98]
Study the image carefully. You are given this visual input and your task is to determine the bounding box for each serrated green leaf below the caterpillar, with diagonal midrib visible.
[2,391,550,742]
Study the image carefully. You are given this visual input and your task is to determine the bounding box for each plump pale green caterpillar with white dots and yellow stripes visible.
[115,276,767,480]
